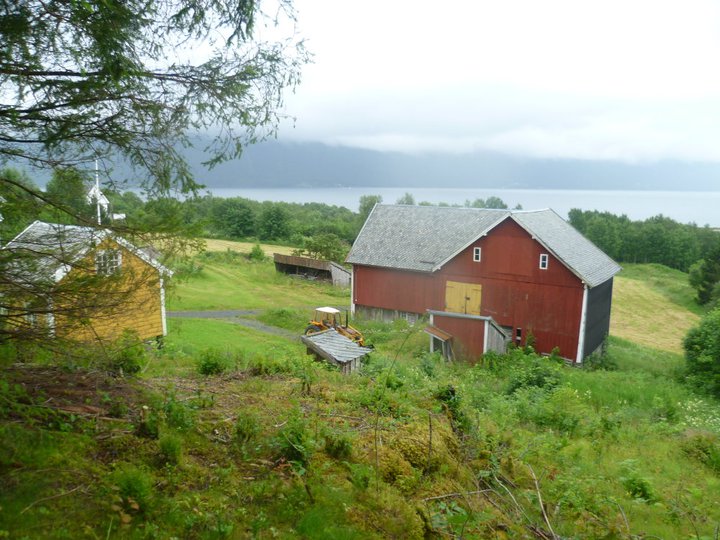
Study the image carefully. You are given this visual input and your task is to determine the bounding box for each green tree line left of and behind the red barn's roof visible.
[0,179,524,260]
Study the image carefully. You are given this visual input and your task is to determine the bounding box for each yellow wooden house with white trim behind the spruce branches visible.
[3,221,172,342]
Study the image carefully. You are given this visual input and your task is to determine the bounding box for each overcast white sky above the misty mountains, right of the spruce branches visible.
[272,0,720,162]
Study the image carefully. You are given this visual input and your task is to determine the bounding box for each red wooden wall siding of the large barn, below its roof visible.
[354,219,592,359]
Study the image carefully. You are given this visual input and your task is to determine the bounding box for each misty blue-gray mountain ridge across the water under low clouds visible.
[186,141,720,191]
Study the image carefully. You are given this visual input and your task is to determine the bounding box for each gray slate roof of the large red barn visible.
[347,205,620,287]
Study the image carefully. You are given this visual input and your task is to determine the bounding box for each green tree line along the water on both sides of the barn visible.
[0,173,720,304]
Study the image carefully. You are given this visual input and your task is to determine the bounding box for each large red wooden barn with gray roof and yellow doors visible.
[347,205,620,362]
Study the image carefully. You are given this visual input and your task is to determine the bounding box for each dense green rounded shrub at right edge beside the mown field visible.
[683,308,720,397]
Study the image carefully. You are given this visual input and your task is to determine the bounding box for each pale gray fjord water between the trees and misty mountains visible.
[211,186,720,227]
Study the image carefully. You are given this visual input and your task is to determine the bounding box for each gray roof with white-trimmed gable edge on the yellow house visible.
[2,221,172,282]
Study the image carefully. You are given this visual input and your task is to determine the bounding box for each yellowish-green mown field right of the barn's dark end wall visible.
[610,264,701,353]
